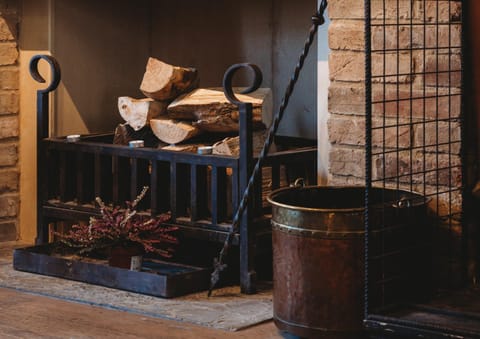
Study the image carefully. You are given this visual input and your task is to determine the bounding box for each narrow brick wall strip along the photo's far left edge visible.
[0,0,19,241]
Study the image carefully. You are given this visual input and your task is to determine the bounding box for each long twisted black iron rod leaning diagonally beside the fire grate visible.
[208,0,328,296]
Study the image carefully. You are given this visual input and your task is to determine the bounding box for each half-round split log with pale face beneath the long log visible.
[150,119,200,144]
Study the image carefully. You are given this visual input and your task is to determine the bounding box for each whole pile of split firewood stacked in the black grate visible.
[114,58,272,155]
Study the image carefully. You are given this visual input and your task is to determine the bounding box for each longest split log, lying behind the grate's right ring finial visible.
[167,88,272,133]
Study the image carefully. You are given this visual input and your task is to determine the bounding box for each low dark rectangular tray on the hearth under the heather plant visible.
[13,244,210,298]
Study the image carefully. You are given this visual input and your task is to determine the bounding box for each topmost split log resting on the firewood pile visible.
[140,58,199,101]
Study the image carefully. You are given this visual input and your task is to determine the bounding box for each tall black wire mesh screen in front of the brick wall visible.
[365,0,480,338]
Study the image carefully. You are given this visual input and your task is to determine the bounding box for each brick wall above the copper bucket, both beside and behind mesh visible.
[328,0,461,208]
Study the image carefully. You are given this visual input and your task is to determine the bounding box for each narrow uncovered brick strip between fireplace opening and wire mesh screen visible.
[328,0,365,185]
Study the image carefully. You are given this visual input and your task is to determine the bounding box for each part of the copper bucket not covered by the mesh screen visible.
[270,188,363,338]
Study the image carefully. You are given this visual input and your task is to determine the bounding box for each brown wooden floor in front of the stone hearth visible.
[0,288,289,339]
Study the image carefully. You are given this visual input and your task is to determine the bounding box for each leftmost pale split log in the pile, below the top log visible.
[118,96,167,131]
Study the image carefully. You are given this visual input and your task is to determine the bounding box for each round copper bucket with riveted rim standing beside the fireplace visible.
[268,187,425,339]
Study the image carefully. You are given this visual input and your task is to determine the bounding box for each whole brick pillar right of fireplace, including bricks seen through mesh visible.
[328,0,464,286]
